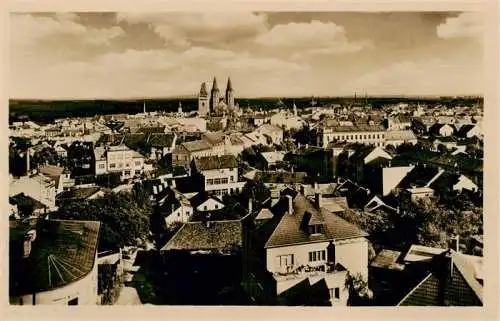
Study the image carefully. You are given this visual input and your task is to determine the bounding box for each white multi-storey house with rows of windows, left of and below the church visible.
[94,145,146,180]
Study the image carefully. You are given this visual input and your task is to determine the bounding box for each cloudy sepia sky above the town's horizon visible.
[9,11,484,99]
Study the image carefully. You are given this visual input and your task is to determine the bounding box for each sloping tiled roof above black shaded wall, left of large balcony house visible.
[161,220,243,251]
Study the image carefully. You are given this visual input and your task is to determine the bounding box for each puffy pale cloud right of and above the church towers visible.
[255,20,371,59]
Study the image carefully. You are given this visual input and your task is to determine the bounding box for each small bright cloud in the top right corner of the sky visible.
[436,12,483,39]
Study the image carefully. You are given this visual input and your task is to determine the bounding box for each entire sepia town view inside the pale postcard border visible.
[6,10,486,308]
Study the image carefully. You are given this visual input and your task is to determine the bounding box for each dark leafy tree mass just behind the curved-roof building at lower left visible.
[53,193,151,251]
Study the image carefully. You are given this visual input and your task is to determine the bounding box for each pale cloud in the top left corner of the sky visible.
[11,13,125,47]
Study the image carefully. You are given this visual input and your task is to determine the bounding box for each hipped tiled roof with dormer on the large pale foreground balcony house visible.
[265,194,368,248]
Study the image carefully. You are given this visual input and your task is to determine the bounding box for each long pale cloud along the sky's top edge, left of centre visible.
[116,12,267,46]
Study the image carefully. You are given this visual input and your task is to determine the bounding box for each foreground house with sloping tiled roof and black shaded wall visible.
[158,219,250,305]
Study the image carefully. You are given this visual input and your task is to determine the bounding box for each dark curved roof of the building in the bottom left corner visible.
[10,220,100,295]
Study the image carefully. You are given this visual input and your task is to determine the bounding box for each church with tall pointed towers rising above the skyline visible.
[198,77,238,117]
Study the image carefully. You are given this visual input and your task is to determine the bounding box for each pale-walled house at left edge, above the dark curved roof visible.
[9,174,57,211]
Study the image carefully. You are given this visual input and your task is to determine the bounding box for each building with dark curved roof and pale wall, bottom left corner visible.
[9,219,100,305]
